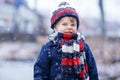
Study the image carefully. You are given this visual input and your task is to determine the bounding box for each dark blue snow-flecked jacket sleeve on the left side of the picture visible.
[34,46,50,80]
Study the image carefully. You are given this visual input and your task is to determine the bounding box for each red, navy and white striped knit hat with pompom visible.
[51,2,79,29]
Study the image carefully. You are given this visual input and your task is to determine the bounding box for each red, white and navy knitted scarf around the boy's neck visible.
[49,32,88,80]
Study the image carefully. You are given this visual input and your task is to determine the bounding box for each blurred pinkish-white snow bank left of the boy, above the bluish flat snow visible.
[0,42,39,60]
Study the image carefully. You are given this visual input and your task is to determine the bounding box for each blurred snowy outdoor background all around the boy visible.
[0,0,120,80]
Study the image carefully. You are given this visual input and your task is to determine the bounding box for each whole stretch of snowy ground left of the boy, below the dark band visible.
[0,42,40,80]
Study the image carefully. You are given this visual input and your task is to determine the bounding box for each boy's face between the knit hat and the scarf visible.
[54,17,77,34]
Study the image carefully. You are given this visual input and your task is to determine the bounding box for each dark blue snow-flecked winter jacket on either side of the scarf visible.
[34,41,98,80]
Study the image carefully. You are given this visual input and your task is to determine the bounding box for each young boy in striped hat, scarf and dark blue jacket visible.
[34,2,98,80]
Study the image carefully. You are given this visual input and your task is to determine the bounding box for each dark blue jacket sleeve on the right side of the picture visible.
[85,44,99,80]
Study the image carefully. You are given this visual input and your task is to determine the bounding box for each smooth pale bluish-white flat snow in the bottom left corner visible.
[0,61,34,80]
